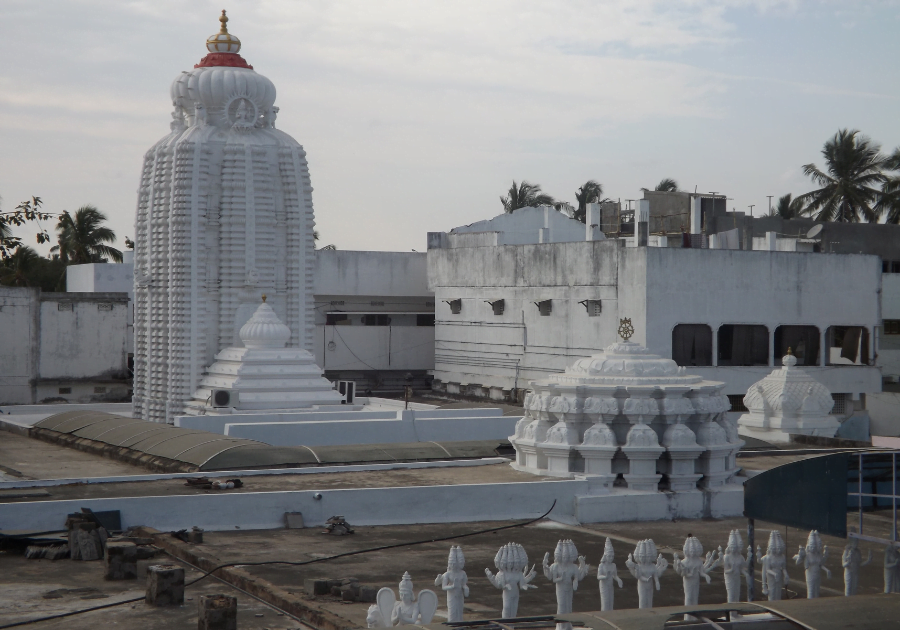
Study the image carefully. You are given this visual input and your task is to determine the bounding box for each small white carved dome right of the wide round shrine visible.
[738,348,840,442]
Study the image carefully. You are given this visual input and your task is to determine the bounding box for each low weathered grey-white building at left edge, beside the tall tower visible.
[0,286,129,405]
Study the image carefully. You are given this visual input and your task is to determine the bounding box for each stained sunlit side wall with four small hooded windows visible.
[428,240,619,391]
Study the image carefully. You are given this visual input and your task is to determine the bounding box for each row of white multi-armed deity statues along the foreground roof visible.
[367,529,900,628]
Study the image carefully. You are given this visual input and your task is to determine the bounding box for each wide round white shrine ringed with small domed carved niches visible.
[510,341,743,492]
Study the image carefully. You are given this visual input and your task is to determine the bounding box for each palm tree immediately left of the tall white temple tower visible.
[50,206,122,265]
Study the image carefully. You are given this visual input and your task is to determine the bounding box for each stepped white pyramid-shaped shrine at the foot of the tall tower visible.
[184,296,342,415]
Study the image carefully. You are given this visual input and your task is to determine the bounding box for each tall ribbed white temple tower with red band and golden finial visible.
[134,11,315,422]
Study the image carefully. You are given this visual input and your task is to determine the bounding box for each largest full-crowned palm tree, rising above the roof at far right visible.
[797,129,889,222]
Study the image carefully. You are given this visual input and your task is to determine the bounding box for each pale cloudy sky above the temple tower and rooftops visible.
[0,0,900,252]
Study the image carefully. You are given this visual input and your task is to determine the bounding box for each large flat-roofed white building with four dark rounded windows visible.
[428,240,881,428]
